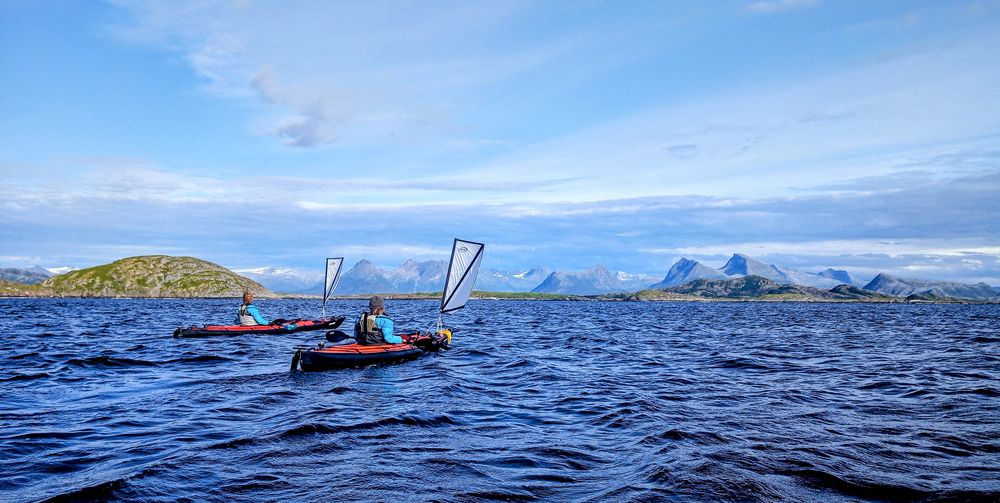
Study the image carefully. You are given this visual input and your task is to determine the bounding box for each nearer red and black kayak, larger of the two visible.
[291,330,451,372]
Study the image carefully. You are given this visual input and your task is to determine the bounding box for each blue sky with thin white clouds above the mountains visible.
[0,0,1000,286]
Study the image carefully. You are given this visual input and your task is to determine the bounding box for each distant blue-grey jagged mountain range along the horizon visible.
[0,253,1000,300]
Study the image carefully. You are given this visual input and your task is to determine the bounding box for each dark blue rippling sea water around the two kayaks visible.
[0,299,1000,501]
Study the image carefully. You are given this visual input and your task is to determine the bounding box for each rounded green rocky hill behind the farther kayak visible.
[40,255,276,297]
